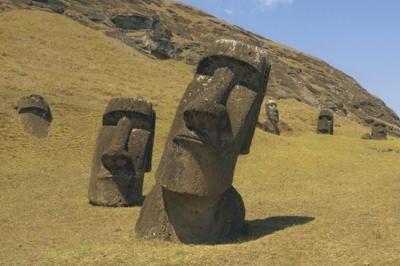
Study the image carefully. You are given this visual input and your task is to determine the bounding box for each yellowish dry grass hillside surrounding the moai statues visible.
[0,10,400,265]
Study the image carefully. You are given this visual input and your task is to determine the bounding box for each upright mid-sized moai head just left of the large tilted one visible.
[88,98,156,206]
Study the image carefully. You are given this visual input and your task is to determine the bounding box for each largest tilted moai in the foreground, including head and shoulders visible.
[135,40,270,244]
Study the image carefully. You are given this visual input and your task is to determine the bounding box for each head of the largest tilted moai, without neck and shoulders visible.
[156,40,269,196]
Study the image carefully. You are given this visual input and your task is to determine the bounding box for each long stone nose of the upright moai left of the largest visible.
[101,117,132,170]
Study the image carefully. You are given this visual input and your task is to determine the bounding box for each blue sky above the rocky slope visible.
[179,0,400,116]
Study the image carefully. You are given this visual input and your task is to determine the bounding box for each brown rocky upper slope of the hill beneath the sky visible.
[0,0,400,136]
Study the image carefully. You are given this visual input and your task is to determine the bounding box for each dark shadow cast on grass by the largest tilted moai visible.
[228,216,315,243]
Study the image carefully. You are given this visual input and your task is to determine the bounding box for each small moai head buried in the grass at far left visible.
[16,94,53,138]
